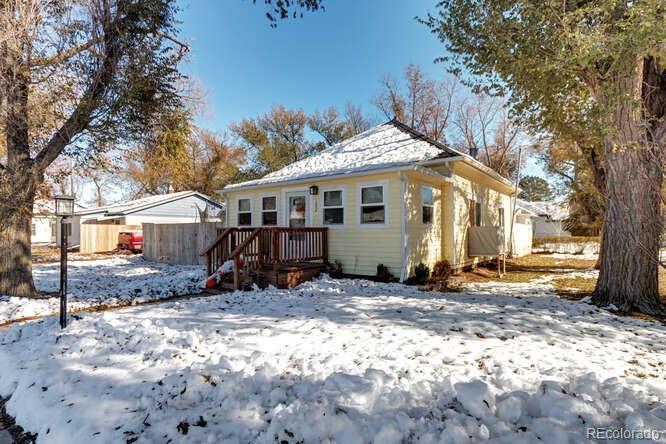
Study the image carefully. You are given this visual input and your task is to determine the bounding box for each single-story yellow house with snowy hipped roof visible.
[221,120,515,281]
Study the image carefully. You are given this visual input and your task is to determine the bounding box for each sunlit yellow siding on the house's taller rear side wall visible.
[452,163,511,268]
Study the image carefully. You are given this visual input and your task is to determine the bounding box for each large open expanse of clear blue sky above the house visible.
[175,0,444,131]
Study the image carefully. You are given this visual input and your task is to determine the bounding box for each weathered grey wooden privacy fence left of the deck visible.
[143,222,222,265]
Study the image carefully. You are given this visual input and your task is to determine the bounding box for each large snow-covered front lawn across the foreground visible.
[0,278,666,444]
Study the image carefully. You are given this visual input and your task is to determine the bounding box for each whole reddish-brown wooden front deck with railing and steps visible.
[201,227,328,289]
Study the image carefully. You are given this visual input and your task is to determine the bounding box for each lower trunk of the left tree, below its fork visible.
[0,173,37,297]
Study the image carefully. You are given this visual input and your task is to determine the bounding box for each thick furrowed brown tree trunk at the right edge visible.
[592,57,666,315]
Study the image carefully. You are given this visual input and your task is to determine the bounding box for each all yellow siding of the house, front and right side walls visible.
[226,162,511,278]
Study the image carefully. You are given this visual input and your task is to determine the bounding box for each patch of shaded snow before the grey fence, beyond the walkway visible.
[0,256,204,324]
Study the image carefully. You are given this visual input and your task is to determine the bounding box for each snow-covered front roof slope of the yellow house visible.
[224,120,464,191]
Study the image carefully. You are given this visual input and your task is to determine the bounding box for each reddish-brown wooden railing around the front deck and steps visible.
[201,227,328,288]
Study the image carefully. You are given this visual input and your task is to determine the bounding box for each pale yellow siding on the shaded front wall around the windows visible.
[226,172,402,278]
